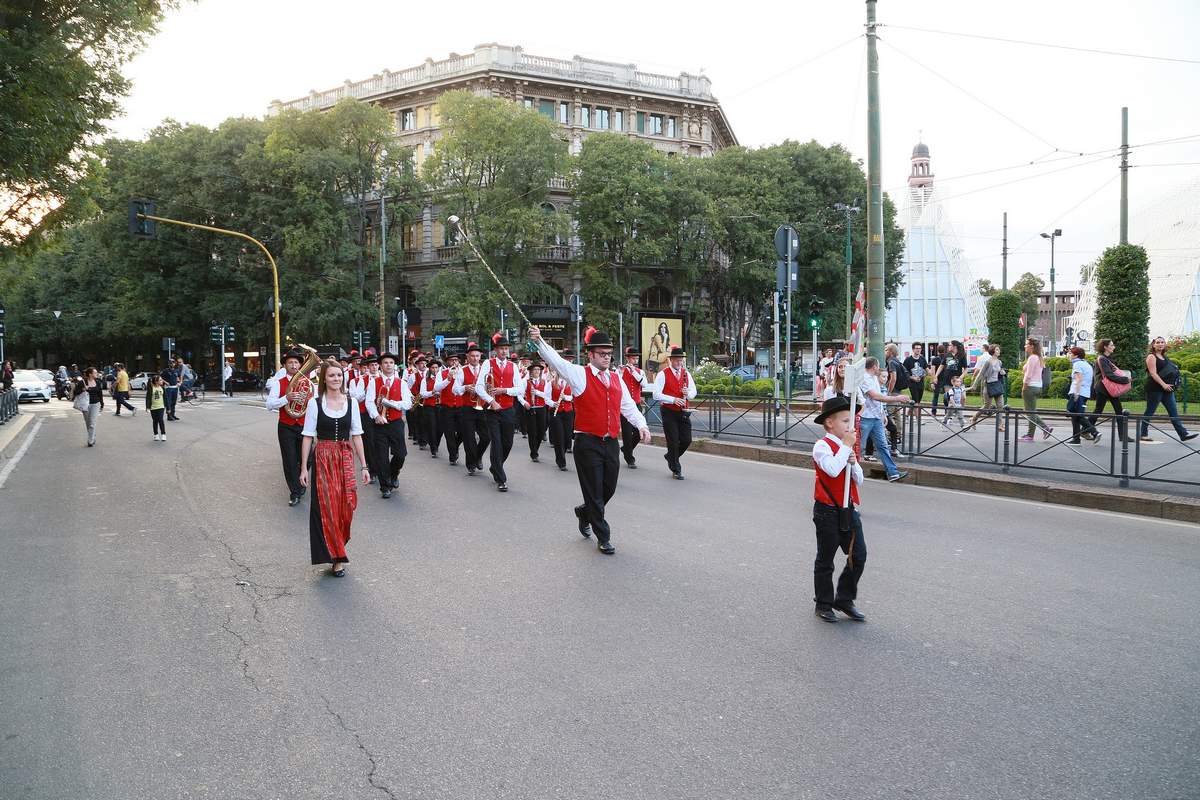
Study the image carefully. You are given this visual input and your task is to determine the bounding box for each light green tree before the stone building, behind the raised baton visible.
[421,91,568,331]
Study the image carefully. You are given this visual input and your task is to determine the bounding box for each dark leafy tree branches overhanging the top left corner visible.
[0,0,178,246]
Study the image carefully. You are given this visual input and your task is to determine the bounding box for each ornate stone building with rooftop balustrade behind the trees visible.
[270,43,737,344]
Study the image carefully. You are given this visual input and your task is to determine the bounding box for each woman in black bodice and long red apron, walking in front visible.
[300,359,371,578]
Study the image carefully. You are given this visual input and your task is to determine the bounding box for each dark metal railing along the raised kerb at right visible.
[646,395,1200,487]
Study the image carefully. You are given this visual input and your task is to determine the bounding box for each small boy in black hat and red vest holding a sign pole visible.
[812,395,866,622]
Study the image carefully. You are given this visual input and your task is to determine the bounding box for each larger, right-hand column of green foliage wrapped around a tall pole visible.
[1094,245,1150,372]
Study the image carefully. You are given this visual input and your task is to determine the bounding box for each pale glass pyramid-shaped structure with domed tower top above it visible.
[884,143,988,353]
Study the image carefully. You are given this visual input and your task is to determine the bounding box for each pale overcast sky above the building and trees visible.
[112,0,1200,288]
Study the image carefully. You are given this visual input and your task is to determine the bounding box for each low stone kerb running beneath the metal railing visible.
[652,433,1200,524]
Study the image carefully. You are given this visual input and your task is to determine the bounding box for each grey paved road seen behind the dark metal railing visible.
[650,401,1200,498]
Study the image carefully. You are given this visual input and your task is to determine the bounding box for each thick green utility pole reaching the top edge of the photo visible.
[866,0,887,361]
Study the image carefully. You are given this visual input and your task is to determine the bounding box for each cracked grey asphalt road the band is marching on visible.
[0,403,1200,800]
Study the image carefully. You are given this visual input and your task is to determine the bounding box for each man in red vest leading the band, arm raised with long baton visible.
[529,325,650,555]
